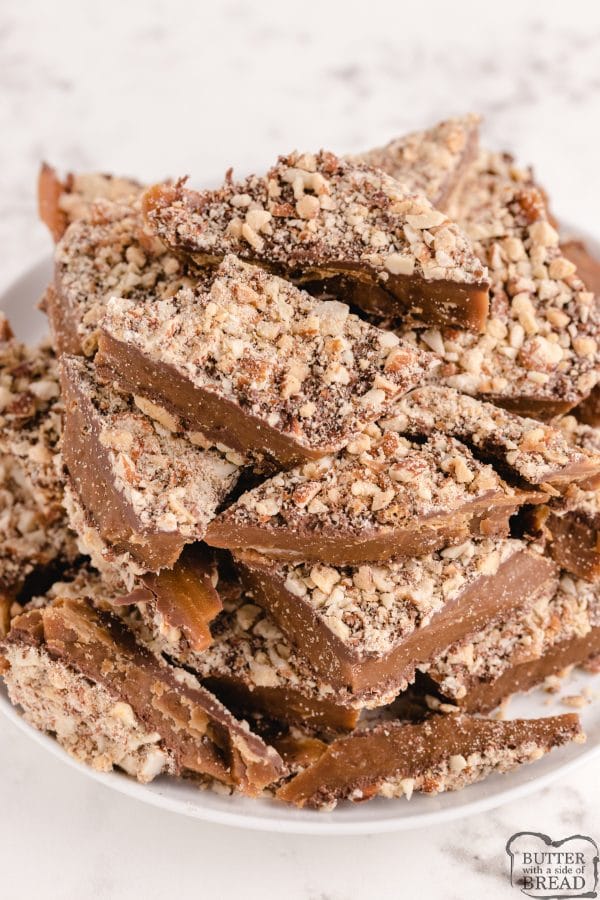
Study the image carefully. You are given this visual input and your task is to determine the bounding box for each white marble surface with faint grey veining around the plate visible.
[0,0,600,900]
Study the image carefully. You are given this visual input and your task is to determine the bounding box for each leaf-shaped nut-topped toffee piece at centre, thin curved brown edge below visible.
[206,430,544,565]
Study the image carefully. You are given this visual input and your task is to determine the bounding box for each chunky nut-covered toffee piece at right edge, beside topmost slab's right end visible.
[398,152,600,421]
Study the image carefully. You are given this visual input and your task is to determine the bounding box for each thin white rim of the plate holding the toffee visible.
[0,239,600,837]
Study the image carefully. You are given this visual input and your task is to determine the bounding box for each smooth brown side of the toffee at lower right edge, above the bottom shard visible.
[452,626,600,713]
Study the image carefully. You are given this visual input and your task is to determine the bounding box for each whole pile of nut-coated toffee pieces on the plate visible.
[0,116,600,809]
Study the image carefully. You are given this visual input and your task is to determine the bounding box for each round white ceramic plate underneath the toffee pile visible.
[0,248,600,835]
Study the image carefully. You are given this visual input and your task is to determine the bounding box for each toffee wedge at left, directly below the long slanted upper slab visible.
[61,356,237,571]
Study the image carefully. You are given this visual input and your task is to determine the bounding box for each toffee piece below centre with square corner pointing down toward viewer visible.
[237,539,557,693]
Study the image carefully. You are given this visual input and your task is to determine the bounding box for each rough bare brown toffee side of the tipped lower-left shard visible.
[5,600,282,794]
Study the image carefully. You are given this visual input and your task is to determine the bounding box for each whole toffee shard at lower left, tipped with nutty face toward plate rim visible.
[0,599,283,795]
